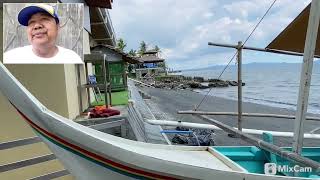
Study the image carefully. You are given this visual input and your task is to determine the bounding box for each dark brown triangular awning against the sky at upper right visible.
[266,4,320,56]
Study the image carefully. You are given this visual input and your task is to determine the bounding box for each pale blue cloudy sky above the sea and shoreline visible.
[109,0,311,69]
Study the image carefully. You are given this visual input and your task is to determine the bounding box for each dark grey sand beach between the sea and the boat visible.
[140,87,320,146]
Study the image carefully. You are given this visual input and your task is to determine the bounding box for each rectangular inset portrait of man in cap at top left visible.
[3,3,83,64]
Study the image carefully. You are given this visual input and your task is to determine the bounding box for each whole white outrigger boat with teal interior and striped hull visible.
[0,0,320,180]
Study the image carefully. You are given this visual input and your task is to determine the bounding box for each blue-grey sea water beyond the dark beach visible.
[182,63,320,114]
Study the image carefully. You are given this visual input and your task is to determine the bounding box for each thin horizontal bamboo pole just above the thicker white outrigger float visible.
[178,111,320,121]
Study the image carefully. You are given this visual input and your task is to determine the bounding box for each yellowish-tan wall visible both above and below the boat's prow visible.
[0,8,75,179]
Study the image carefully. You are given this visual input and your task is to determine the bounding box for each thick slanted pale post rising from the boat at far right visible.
[293,0,320,154]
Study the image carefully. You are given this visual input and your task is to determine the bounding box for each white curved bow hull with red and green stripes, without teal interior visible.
[0,63,316,180]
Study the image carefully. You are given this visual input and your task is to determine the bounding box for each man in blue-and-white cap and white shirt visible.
[3,4,83,64]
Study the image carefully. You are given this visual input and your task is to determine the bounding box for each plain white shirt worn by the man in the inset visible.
[3,45,83,64]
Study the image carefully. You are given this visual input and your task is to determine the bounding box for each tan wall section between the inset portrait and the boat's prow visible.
[2,64,69,117]
